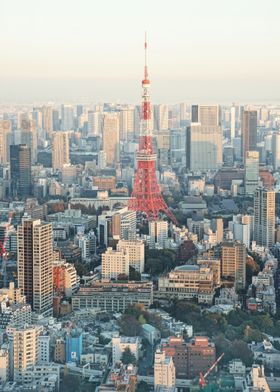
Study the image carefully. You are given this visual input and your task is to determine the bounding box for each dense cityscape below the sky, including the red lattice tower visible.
[0,3,280,392]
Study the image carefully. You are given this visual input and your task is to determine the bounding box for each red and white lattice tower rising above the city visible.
[128,37,176,223]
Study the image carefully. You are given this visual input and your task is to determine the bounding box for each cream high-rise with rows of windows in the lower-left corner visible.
[7,325,42,383]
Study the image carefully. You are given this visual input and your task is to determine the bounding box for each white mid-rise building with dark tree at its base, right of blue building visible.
[112,336,140,366]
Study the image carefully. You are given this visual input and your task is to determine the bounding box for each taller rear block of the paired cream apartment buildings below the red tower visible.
[117,240,145,273]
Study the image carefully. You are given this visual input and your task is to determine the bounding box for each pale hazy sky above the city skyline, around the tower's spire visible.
[0,0,280,103]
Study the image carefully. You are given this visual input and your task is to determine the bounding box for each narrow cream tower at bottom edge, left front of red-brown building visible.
[154,349,176,390]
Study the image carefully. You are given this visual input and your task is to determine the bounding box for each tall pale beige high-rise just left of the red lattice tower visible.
[102,113,120,166]
